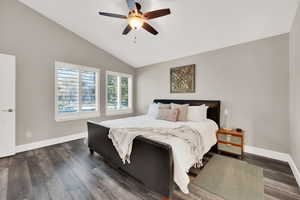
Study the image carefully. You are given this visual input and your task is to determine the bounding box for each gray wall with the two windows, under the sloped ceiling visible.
[0,0,135,145]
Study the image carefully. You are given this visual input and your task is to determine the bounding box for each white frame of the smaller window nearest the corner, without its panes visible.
[105,71,133,116]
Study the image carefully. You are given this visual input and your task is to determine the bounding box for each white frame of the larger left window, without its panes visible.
[54,61,101,122]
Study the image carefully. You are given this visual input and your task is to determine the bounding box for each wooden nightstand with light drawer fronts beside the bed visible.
[217,129,244,159]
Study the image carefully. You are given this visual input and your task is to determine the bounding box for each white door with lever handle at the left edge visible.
[0,54,16,158]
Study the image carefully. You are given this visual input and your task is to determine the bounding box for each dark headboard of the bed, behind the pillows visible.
[153,99,221,127]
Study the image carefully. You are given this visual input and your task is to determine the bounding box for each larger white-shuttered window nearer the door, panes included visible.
[55,62,100,121]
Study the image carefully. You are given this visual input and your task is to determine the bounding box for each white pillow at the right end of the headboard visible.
[187,104,208,122]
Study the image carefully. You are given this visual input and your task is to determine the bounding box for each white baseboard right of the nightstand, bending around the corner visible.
[245,146,300,187]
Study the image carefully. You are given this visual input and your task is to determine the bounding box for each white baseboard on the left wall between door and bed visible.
[16,132,87,153]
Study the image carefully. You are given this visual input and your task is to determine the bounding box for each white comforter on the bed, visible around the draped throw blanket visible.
[100,115,218,193]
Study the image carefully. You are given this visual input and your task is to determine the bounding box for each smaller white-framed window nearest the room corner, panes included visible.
[106,72,132,115]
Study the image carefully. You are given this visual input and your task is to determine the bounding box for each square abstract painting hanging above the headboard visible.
[170,65,196,93]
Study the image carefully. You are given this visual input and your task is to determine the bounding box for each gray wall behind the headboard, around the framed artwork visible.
[136,34,289,152]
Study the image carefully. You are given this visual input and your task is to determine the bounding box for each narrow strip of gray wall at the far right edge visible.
[290,7,300,172]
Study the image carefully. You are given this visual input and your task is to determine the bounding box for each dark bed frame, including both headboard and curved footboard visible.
[87,99,221,199]
